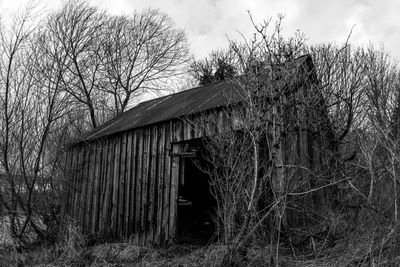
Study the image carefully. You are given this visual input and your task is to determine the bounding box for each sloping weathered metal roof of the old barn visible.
[75,55,312,144]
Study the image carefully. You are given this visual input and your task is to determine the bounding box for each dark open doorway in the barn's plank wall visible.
[177,139,216,244]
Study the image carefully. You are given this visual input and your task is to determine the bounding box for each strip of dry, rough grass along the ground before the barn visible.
[0,231,400,267]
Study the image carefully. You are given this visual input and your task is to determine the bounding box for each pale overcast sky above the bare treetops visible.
[0,0,400,58]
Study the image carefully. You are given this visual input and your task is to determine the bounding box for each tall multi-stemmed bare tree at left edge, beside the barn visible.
[0,5,72,258]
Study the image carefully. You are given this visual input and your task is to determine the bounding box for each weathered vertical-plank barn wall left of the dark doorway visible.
[63,111,222,245]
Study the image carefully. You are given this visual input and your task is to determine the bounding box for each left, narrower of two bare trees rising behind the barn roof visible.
[47,1,106,130]
